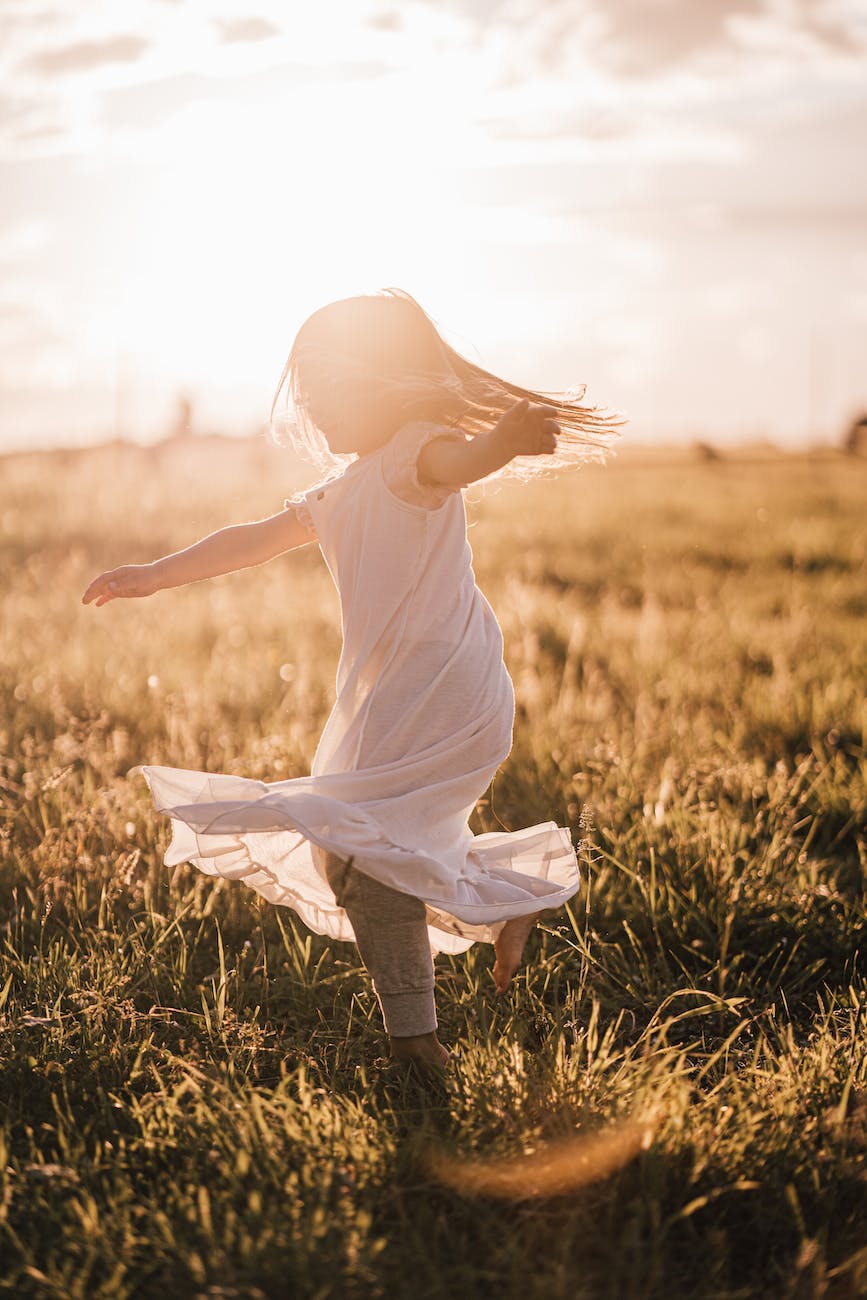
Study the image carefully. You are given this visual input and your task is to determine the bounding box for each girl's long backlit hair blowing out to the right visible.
[270,289,628,478]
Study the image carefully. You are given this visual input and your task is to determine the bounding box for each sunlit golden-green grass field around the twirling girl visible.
[0,443,867,1300]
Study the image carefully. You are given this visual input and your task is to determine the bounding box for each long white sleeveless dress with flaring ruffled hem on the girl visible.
[133,423,580,953]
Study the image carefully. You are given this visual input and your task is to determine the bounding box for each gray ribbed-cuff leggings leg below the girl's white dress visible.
[313,844,437,1039]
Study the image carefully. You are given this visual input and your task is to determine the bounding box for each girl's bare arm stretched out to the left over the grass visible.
[82,507,313,605]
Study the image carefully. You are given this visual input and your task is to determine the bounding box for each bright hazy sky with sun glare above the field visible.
[0,0,867,450]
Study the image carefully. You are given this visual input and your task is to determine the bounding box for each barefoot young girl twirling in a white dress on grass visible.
[82,289,625,1067]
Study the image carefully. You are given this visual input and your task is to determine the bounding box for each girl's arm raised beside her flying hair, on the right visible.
[419,398,560,488]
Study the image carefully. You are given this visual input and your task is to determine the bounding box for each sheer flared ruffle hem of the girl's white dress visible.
[129,766,580,953]
